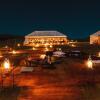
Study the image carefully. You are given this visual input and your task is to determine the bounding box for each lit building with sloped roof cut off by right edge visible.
[90,31,100,44]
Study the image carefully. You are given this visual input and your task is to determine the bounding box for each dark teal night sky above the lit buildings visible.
[0,0,100,38]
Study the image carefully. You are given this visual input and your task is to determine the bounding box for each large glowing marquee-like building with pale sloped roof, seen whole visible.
[24,31,68,46]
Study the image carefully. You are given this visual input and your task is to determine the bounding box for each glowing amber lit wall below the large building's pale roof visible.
[24,36,68,46]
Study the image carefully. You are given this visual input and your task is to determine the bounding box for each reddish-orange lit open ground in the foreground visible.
[0,58,100,100]
